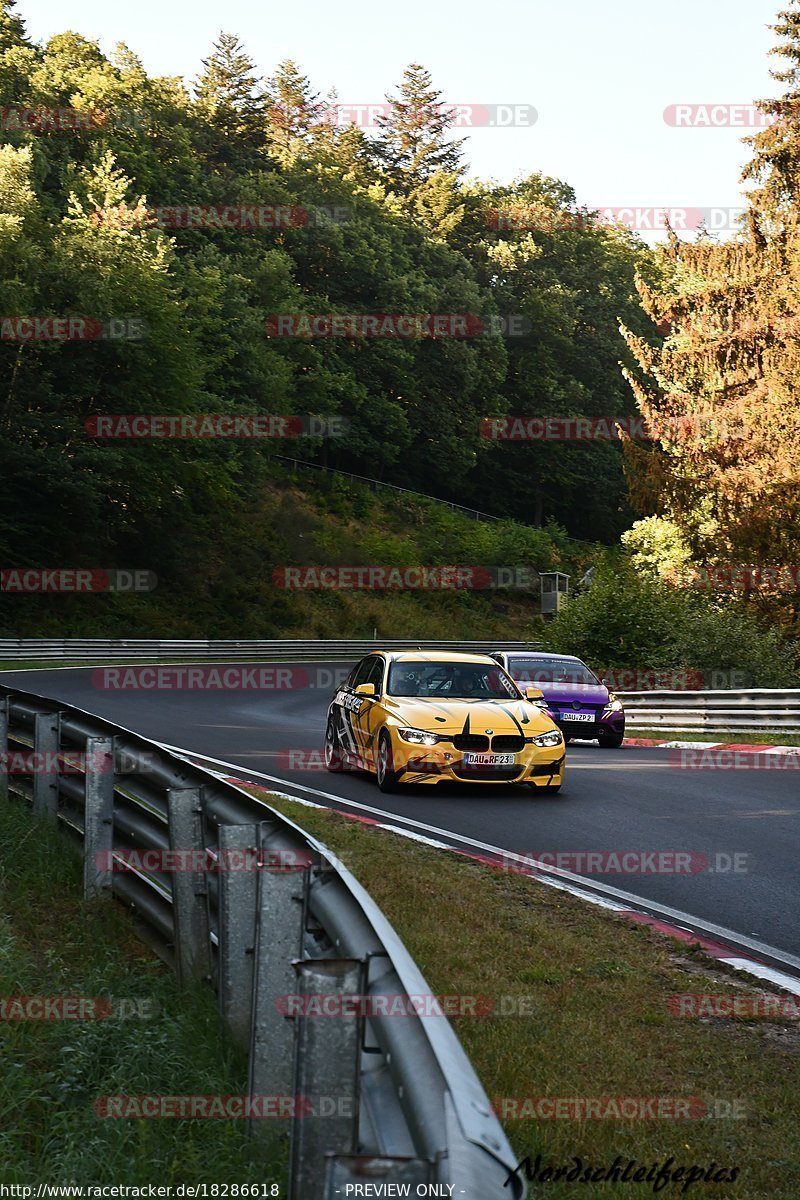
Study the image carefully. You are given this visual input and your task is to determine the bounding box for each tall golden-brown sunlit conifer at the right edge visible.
[626,0,800,576]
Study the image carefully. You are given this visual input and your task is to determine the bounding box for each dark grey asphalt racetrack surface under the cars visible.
[0,664,800,955]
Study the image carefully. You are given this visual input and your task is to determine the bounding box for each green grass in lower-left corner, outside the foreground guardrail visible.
[0,800,283,1190]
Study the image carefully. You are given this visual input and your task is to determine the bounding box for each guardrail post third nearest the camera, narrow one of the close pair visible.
[217,824,258,1045]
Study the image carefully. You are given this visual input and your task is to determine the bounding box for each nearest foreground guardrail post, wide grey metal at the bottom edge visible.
[289,959,366,1200]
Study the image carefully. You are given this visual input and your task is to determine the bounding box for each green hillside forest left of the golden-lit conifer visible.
[0,0,643,624]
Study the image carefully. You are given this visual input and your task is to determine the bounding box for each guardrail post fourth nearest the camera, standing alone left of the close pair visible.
[167,787,211,984]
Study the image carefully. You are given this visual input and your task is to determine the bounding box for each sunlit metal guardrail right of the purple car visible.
[619,688,800,733]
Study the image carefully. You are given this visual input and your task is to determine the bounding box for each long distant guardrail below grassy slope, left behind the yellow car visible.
[0,637,541,662]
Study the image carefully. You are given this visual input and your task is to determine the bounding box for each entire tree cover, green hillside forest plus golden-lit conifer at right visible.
[0,0,800,667]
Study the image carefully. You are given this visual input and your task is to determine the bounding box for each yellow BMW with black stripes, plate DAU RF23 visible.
[325,650,565,794]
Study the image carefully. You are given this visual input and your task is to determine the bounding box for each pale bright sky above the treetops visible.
[18,0,781,240]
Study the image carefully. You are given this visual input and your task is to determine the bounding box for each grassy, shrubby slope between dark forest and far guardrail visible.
[0,464,593,640]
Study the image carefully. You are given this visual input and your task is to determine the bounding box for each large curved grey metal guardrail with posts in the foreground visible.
[0,685,524,1200]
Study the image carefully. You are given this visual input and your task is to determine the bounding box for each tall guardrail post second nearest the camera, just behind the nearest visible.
[247,826,309,1140]
